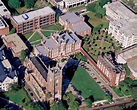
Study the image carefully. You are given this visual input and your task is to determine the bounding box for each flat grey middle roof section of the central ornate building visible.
[44,38,58,50]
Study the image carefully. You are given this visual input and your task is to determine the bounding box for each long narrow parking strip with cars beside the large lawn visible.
[79,62,119,99]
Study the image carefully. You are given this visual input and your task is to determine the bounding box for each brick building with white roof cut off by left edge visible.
[0,16,9,36]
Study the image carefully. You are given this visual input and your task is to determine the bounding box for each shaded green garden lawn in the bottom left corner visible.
[4,88,44,110]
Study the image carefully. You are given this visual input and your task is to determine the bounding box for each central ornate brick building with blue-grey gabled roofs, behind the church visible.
[34,33,82,59]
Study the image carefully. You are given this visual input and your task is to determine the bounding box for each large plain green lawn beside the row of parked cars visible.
[72,67,106,101]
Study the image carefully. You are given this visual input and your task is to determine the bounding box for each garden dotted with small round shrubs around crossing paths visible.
[83,31,120,61]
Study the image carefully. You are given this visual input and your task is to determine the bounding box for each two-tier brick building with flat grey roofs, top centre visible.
[59,13,91,36]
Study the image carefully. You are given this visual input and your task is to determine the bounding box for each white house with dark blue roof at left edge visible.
[0,59,18,92]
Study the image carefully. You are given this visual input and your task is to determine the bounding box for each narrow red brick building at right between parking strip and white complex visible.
[97,54,126,86]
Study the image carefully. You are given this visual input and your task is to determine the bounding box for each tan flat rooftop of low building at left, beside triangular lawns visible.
[3,33,27,53]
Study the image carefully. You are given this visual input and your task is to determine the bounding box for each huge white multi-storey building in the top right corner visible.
[104,1,137,48]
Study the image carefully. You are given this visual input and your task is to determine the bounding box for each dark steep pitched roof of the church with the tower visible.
[31,57,48,81]
